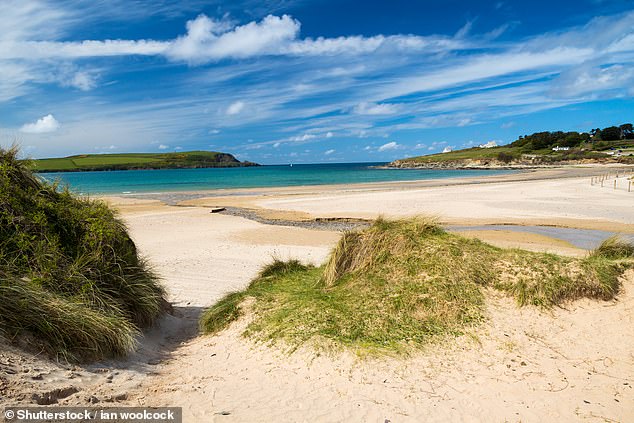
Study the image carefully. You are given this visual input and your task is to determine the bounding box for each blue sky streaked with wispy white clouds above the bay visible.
[0,0,634,164]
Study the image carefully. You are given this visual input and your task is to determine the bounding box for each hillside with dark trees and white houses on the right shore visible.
[388,124,634,169]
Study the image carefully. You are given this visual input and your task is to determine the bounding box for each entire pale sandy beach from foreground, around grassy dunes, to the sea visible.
[0,168,634,422]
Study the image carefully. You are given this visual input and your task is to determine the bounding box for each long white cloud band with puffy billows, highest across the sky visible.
[0,8,467,64]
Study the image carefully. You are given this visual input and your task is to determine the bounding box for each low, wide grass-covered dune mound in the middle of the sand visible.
[200,218,634,352]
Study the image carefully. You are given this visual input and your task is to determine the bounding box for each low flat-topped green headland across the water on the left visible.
[31,151,258,172]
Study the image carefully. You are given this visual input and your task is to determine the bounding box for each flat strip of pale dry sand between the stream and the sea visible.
[180,173,634,233]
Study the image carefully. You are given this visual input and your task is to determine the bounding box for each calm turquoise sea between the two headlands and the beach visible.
[40,163,512,194]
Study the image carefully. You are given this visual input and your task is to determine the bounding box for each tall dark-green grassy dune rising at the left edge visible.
[0,150,167,360]
